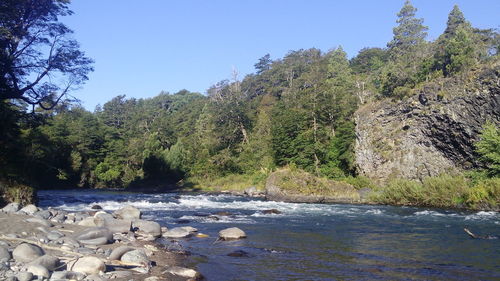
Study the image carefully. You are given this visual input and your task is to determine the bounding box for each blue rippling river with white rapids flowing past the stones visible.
[39,190,500,280]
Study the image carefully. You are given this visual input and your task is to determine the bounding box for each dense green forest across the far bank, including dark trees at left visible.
[0,1,500,208]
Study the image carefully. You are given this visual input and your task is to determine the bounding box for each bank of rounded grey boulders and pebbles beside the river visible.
[0,203,213,281]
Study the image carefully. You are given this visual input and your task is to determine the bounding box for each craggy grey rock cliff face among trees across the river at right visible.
[355,67,500,183]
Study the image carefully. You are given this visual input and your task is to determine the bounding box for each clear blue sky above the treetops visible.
[62,0,500,110]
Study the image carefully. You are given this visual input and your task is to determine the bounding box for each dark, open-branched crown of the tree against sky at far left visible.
[0,0,93,109]
